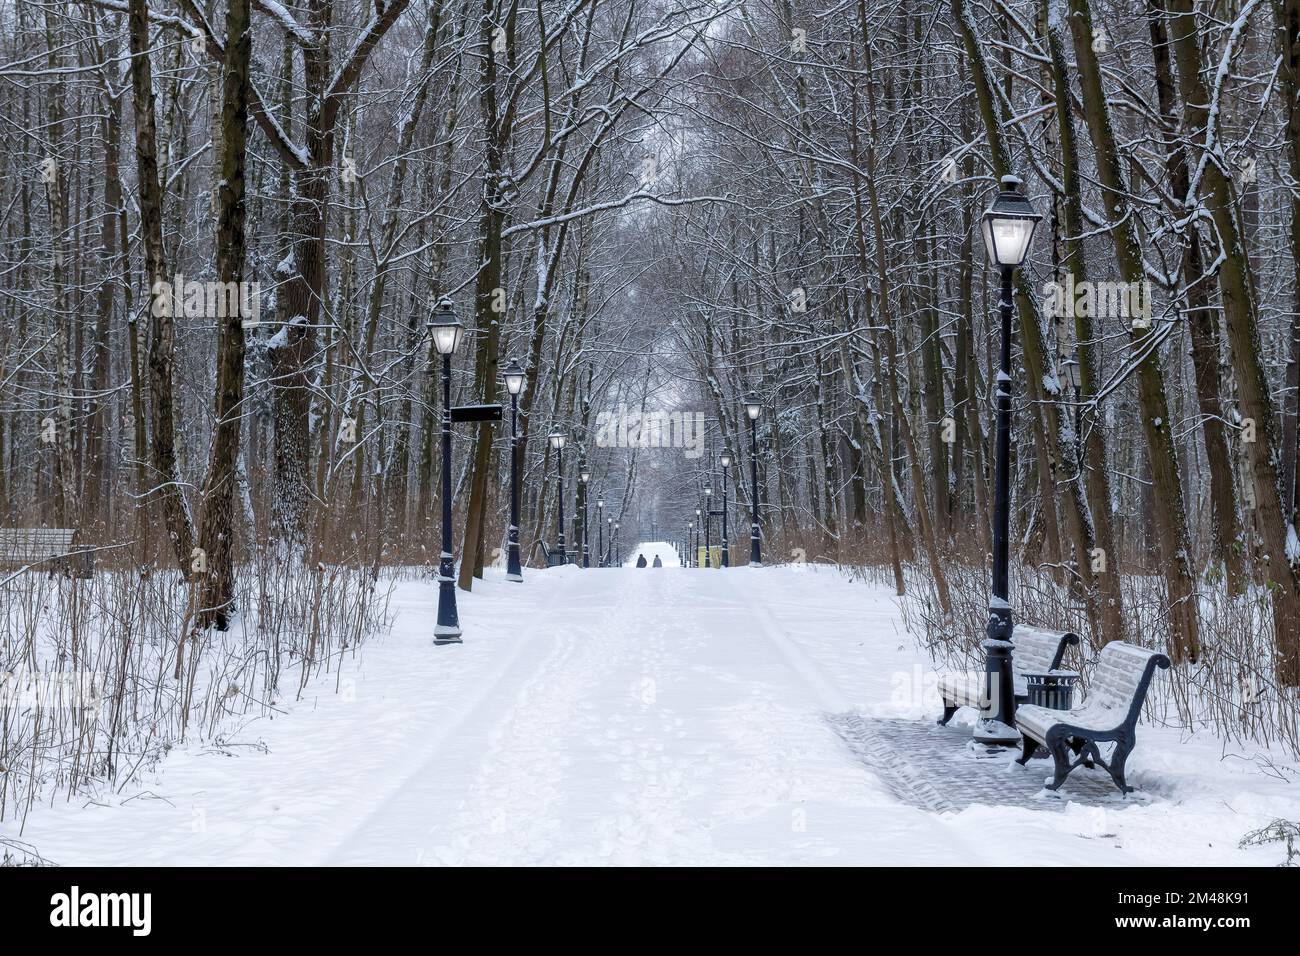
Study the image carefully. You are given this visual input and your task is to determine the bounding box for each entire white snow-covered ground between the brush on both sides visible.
[10,544,1300,865]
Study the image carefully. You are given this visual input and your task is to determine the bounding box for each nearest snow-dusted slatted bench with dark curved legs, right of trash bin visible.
[1015,641,1169,793]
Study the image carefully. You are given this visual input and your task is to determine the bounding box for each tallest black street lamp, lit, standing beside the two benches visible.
[974,176,1041,745]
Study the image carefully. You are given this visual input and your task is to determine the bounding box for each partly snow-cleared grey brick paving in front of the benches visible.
[828,714,1149,813]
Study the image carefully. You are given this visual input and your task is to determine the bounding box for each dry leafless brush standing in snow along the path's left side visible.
[0,561,390,819]
